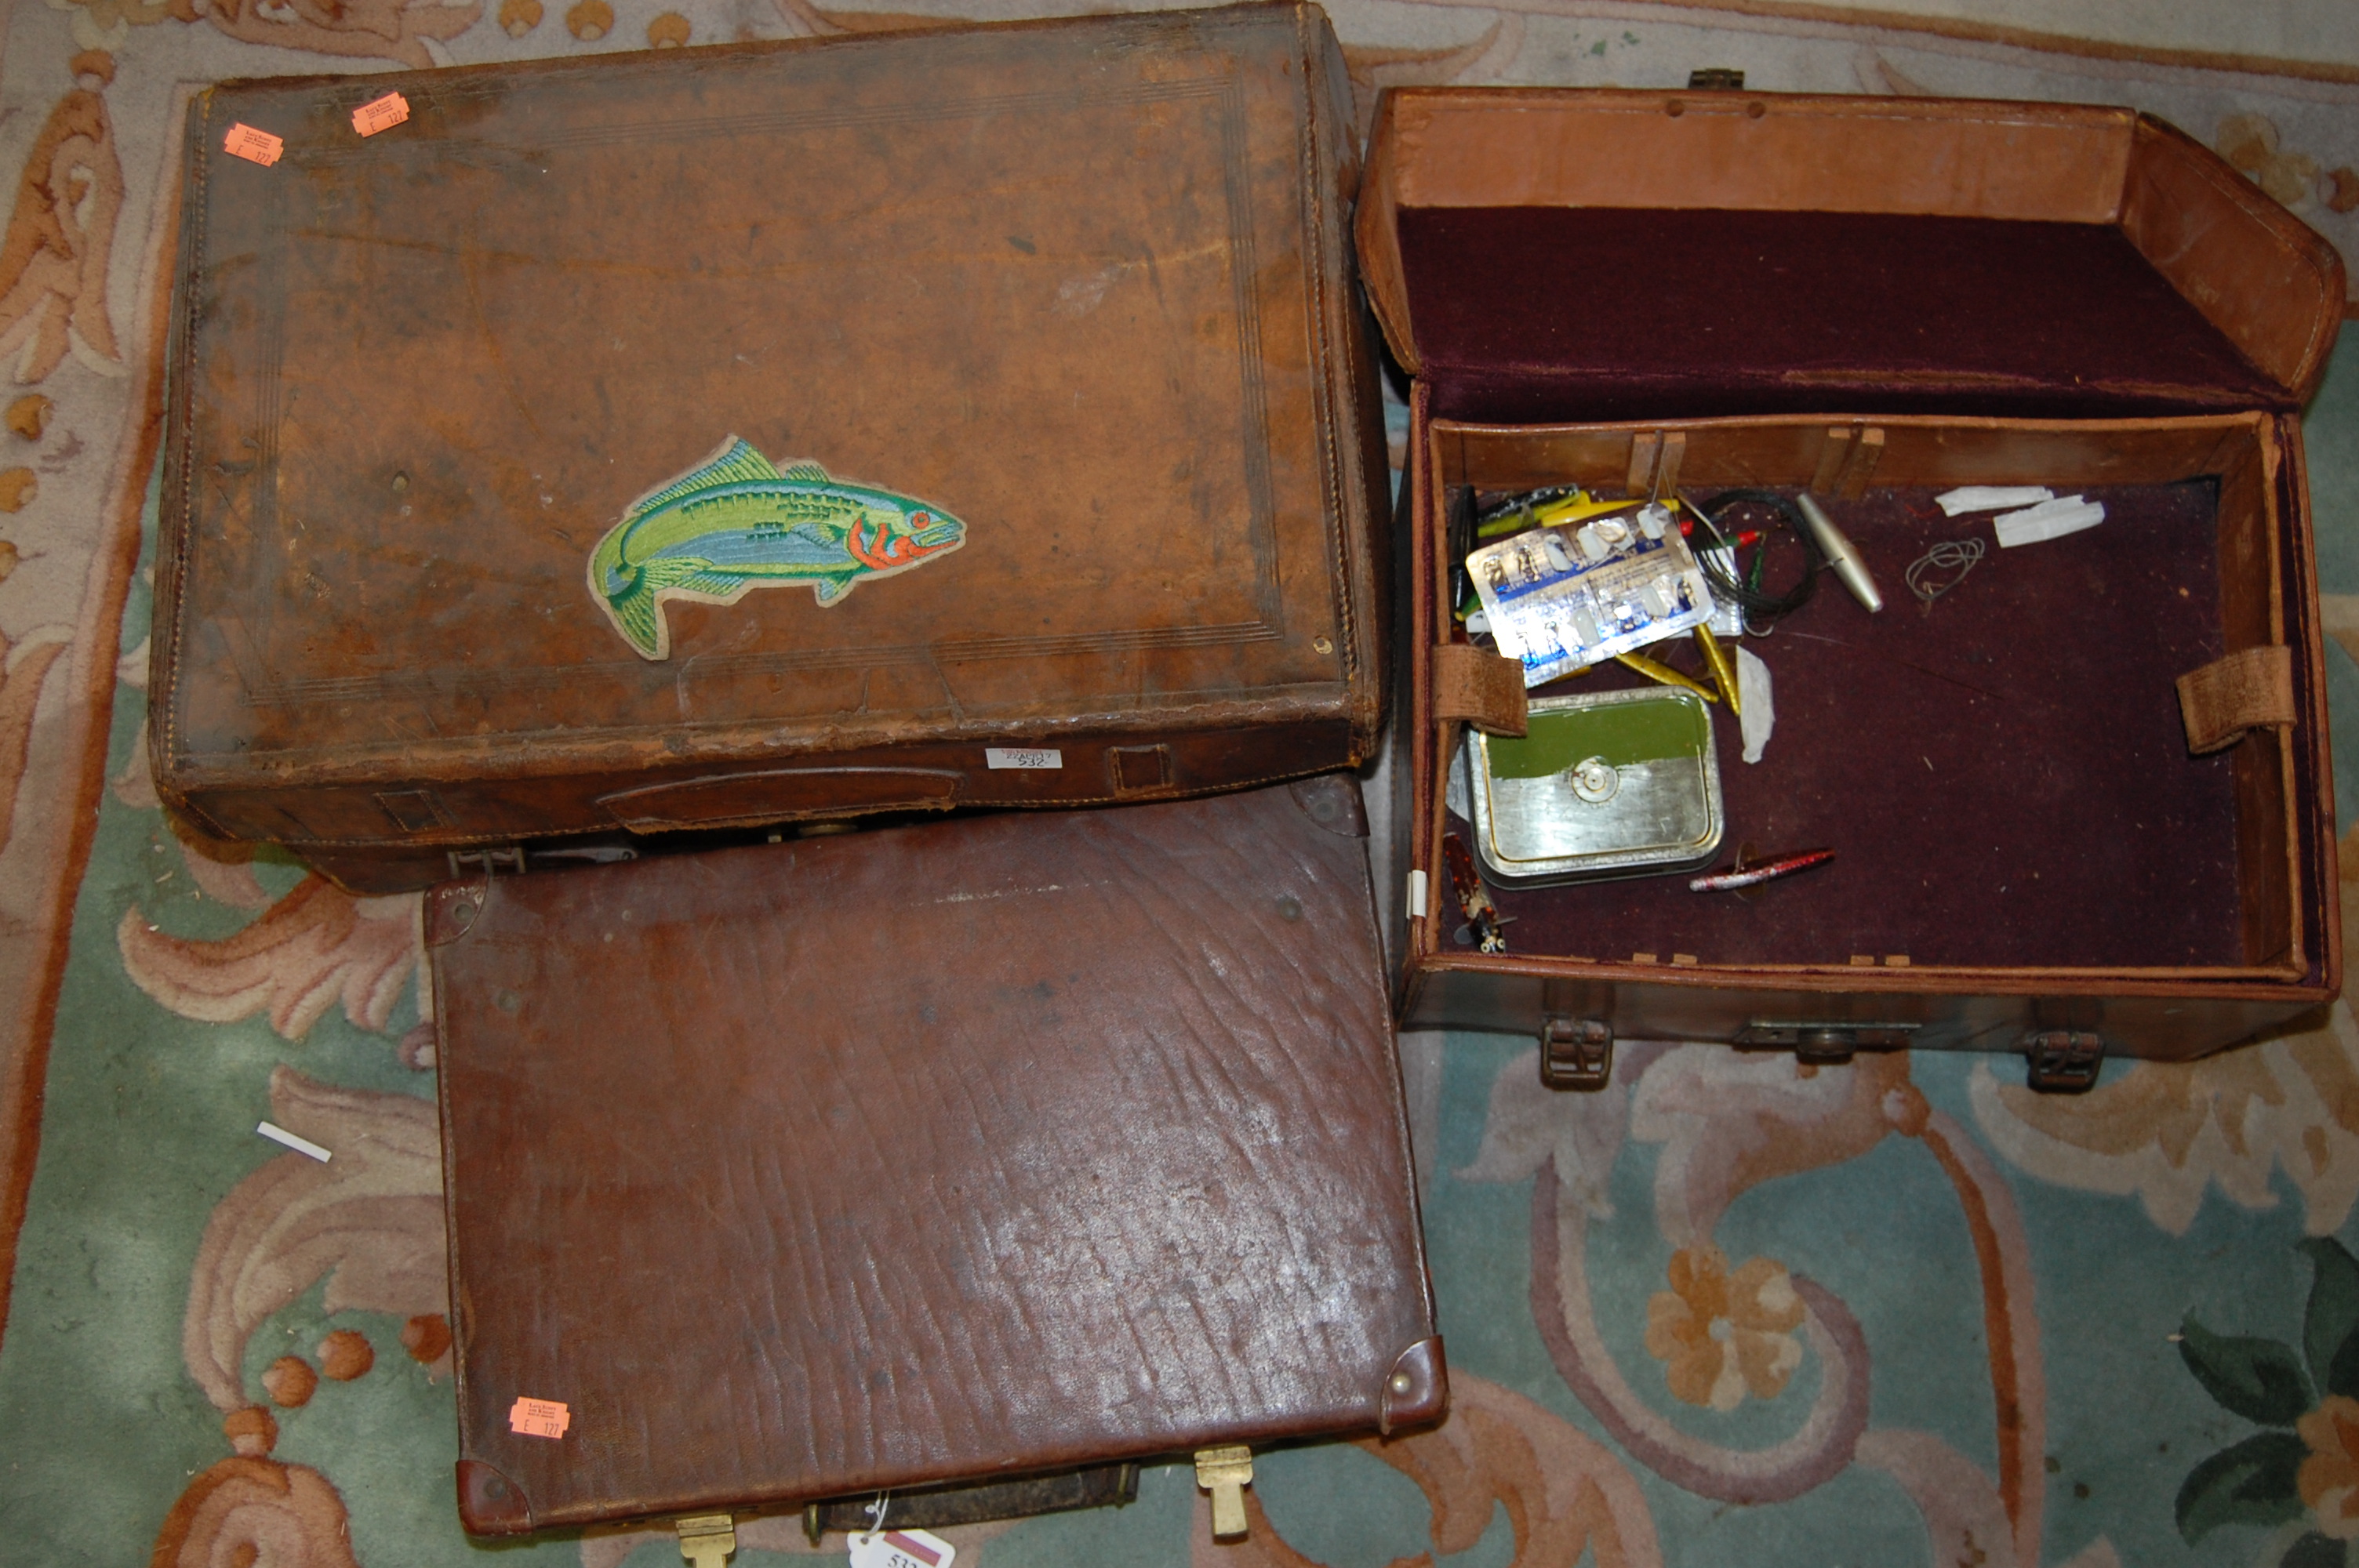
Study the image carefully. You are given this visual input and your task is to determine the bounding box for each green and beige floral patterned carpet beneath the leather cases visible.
[0,0,2359,1568]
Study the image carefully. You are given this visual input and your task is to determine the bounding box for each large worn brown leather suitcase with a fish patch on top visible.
[151,5,1385,891]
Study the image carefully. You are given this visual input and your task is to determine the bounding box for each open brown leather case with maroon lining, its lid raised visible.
[1359,89,2343,1087]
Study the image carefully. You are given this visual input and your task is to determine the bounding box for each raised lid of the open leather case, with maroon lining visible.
[1359,89,2343,422]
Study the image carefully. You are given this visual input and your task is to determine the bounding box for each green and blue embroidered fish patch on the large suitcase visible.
[590,436,967,658]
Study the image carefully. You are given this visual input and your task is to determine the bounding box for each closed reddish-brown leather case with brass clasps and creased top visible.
[424,775,1446,1535]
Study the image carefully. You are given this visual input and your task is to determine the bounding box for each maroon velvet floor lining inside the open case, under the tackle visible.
[1451,481,2246,967]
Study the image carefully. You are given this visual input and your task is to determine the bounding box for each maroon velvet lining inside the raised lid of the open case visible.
[1399,208,2295,424]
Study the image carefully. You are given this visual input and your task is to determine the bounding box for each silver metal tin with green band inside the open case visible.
[1465,686,1722,887]
